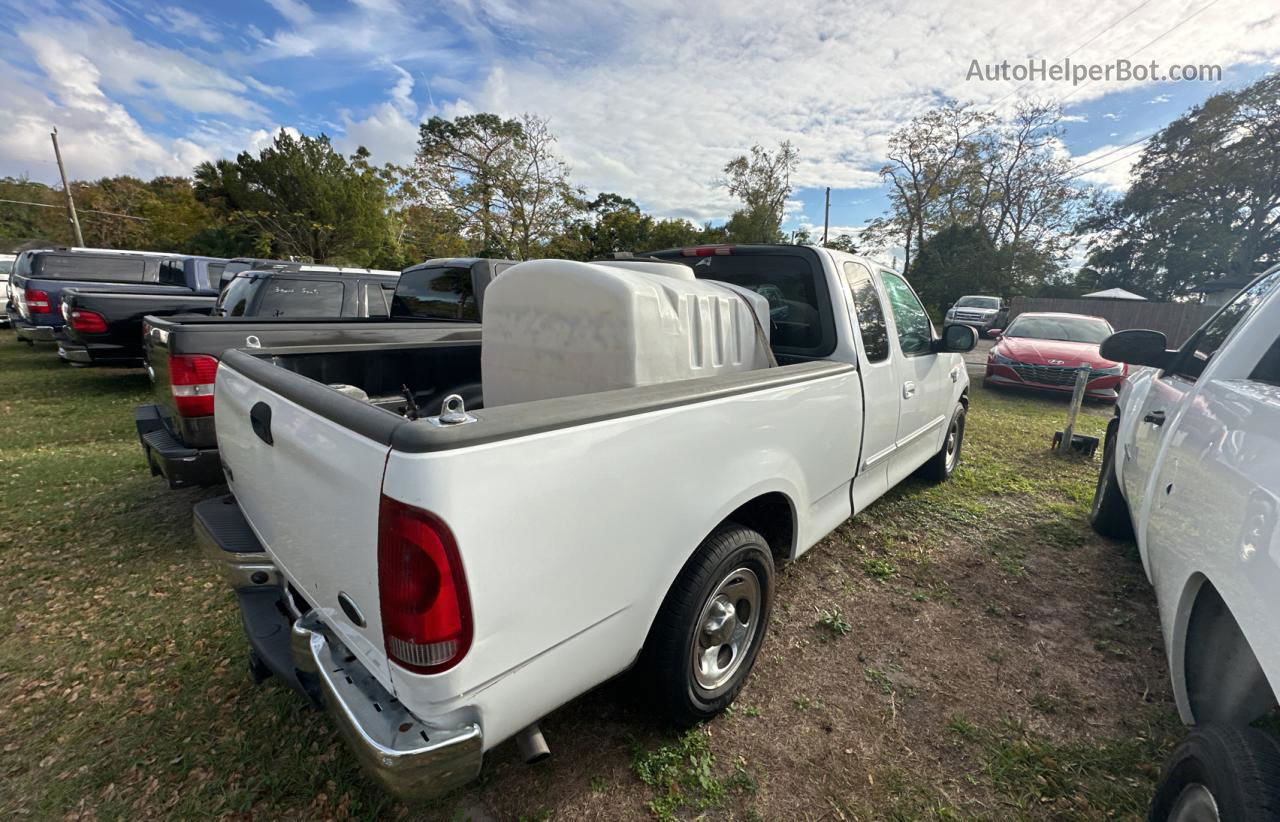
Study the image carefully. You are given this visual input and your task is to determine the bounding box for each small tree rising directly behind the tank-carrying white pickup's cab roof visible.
[722,141,800,242]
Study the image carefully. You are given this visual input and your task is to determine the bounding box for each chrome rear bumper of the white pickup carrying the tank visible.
[193,496,484,800]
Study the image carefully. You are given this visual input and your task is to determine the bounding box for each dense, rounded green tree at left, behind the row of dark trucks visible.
[195,131,392,265]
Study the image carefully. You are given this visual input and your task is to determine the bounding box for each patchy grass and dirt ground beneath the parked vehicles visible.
[0,333,1180,819]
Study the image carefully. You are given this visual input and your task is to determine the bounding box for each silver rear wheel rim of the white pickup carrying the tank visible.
[691,567,763,691]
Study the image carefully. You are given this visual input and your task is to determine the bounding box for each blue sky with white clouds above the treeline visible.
[0,0,1280,253]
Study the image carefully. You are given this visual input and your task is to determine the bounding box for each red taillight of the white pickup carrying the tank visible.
[378,497,472,673]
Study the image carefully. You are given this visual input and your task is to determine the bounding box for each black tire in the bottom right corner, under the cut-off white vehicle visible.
[1147,725,1280,822]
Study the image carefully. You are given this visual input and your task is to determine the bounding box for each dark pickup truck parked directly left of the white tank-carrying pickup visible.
[134,257,513,488]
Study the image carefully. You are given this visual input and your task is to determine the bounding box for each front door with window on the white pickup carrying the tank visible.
[881,270,952,484]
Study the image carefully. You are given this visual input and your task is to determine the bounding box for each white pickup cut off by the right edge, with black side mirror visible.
[1091,266,1280,821]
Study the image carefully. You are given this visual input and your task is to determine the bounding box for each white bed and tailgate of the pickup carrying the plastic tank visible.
[216,342,863,749]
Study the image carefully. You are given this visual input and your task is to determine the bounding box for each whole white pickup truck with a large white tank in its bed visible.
[195,246,977,798]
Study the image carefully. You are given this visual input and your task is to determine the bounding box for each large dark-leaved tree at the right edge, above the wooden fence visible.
[1079,74,1280,298]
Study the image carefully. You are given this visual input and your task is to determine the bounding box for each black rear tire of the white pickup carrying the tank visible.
[644,522,773,726]
